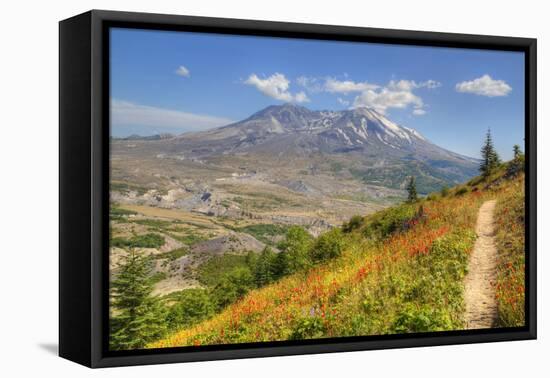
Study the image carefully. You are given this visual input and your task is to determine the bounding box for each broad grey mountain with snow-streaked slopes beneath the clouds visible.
[141,104,478,193]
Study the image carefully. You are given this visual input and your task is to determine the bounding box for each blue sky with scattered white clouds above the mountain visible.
[111,29,524,159]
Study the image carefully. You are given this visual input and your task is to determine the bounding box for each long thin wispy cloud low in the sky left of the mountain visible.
[111,99,233,134]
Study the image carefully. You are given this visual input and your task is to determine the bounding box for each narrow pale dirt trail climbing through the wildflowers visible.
[464,200,497,329]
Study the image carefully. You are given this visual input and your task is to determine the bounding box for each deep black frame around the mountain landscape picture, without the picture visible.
[59,10,537,368]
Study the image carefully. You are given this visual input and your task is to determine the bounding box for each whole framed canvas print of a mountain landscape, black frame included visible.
[59,11,536,367]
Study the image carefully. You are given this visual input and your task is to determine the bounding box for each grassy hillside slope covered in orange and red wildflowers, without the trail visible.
[147,166,525,348]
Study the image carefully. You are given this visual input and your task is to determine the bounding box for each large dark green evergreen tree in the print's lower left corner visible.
[110,249,165,350]
